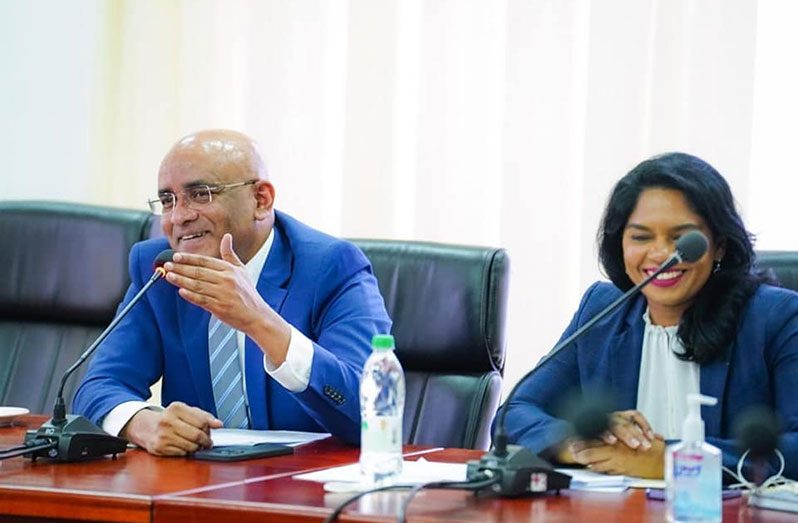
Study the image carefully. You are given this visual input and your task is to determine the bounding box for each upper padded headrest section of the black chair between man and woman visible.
[354,240,509,372]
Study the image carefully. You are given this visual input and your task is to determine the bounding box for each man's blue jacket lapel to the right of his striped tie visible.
[247,222,293,429]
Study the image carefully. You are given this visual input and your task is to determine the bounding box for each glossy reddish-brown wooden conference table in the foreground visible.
[0,416,798,523]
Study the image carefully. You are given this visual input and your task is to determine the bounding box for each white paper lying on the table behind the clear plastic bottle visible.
[294,458,466,492]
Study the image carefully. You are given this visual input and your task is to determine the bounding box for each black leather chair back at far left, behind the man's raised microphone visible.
[0,201,151,413]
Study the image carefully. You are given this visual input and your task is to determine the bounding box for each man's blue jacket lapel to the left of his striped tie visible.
[175,293,216,416]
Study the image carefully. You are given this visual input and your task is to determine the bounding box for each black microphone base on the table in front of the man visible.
[25,415,127,462]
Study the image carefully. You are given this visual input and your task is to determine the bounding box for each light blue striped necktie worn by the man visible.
[208,316,249,429]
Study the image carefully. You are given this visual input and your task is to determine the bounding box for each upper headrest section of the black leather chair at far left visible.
[0,201,155,324]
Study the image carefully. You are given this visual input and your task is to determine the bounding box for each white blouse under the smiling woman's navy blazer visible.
[637,309,700,439]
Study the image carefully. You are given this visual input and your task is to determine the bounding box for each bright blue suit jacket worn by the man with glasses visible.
[74,212,391,442]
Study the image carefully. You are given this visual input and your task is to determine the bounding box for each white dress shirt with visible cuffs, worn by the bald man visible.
[101,233,313,436]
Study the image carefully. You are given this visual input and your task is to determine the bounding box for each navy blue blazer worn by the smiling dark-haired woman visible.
[503,283,798,478]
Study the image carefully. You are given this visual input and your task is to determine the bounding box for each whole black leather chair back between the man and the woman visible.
[354,240,509,449]
